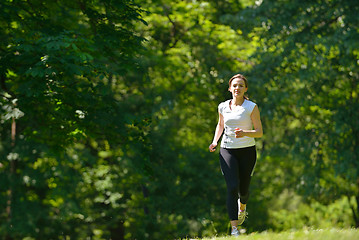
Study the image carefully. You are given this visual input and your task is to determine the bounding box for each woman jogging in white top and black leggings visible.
[209,74,263,236]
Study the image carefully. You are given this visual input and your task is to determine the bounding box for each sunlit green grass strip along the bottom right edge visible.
[202,229,359,240]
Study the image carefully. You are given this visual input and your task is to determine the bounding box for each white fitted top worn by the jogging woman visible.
[218,99,256,148]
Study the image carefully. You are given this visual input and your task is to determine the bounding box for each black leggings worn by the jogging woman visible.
[219,146,257,220]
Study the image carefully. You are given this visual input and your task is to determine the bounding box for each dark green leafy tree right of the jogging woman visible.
[228,0,359,226]
